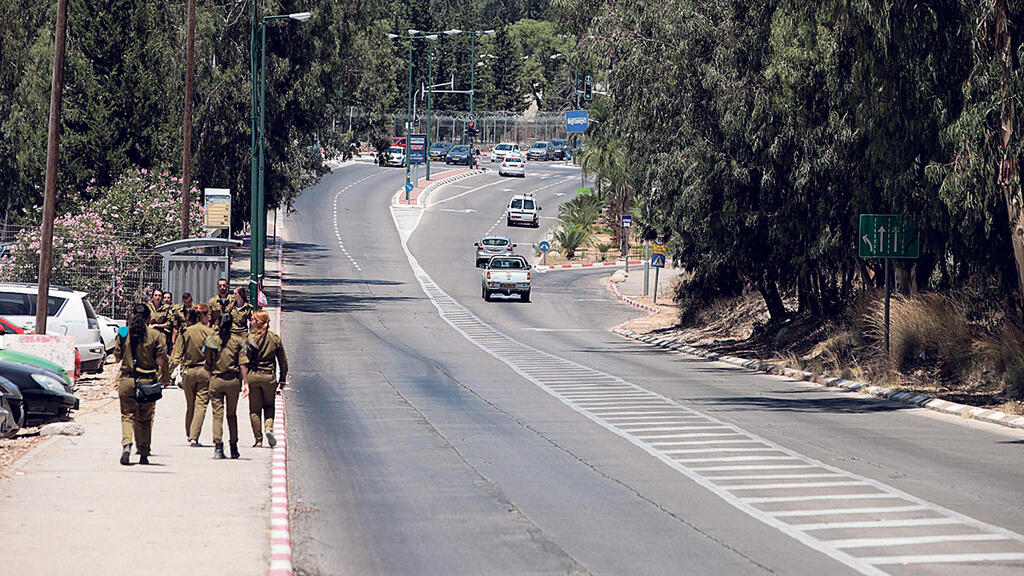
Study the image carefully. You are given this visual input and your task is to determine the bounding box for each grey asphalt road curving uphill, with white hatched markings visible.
[283,157,1024,575]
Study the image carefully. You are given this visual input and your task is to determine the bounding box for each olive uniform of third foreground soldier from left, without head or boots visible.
[204,334,249,444]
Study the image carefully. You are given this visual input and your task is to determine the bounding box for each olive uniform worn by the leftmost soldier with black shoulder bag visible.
[114,327,167,456]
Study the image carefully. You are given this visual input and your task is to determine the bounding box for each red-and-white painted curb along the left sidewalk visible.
[266,215,294,576]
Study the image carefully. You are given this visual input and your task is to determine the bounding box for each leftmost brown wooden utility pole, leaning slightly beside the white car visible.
[36,0,68,334]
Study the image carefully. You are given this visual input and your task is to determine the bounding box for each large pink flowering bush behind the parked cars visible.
[0,170,203,317]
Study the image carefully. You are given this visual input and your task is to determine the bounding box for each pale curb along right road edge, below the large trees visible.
[609,311,1024,429]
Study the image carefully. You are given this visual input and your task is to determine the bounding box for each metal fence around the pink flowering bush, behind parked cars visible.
[0,227,161,319]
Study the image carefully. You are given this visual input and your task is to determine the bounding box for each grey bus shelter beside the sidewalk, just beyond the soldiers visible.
[155,238,242,303]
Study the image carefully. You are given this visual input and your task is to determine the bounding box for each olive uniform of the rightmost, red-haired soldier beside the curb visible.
[245,331,288,442]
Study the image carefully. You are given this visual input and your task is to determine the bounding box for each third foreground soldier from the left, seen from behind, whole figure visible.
[203,315,249,460]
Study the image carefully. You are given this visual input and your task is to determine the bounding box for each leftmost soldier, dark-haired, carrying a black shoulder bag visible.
[114,303,167,465]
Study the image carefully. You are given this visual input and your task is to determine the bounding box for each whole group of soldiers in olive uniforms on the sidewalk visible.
[115,279,288,465]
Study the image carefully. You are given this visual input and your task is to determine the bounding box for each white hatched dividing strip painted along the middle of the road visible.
[392,194,1024,575]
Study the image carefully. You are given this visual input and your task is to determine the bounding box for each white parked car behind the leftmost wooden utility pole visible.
[0,282,106,373]
